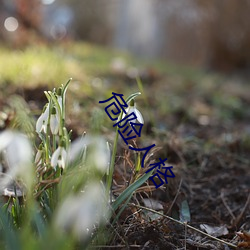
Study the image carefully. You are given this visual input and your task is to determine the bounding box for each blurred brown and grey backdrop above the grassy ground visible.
[0,0,250,72]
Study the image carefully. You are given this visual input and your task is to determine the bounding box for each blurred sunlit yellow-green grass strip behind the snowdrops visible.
[0,43,129,86]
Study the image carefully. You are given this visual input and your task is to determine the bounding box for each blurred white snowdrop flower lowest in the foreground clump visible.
[55,182,109,240]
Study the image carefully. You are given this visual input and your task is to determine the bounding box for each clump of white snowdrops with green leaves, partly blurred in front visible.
[0,80,154,250]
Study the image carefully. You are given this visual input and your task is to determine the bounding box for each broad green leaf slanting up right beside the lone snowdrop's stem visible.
[112,170,154,211]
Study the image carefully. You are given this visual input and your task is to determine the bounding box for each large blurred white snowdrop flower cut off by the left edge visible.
[0,130,33,188]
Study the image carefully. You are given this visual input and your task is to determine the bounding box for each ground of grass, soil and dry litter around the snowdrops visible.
[0,44,250,250]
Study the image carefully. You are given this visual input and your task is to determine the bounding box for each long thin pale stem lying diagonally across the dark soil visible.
[128,203,237,248]
